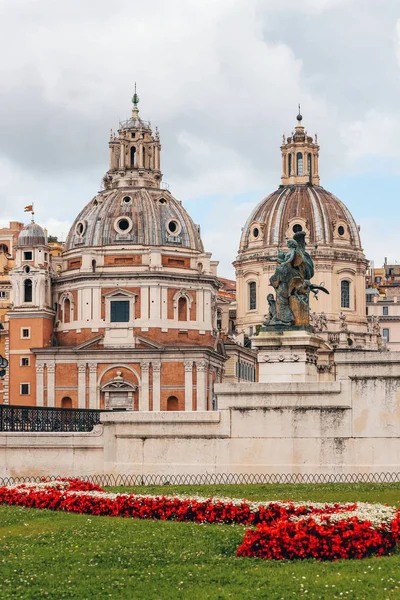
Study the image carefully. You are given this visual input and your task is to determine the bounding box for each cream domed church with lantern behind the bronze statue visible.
[234,114,377,348]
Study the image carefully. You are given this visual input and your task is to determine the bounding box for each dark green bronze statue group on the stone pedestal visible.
[264,231,329,327]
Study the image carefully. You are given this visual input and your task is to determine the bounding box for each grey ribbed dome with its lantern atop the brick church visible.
[65,90,204,252]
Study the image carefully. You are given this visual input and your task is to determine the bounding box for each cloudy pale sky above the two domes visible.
[0,0,400,276]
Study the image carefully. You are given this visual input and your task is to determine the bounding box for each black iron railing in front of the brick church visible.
[0,404,102,432]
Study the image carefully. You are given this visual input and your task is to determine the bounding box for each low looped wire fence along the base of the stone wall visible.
[0,472,400,487]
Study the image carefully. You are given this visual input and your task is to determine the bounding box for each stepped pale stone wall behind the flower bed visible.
[0,352,400,477]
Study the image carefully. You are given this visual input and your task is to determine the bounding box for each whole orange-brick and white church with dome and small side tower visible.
[4,93,226,411]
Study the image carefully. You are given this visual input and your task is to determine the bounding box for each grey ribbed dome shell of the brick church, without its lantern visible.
[65,188,203,252]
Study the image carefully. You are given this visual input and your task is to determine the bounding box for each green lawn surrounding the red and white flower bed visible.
[0,484,400,600]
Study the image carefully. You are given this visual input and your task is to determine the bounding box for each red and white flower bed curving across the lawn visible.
[0,479,400,560]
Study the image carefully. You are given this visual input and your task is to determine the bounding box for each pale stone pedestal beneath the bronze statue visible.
[252,326,327,383]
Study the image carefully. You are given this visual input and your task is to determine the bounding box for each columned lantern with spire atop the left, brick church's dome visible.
[107,84,162,189]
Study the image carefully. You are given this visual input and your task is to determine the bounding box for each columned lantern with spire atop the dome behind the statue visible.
[281,104,319,185]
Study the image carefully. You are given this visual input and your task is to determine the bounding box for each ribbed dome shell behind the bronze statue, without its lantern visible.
[240,185,361,252]
